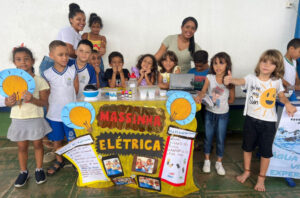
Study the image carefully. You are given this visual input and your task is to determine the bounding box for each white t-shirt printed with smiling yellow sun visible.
[242,74,284,122]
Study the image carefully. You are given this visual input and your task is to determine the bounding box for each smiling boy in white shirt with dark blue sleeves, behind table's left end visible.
[68,40,97,100]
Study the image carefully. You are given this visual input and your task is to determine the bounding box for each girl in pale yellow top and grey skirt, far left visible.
[6,47,51,187]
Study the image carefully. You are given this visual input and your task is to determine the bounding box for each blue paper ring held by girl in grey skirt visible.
[0,69,35,97]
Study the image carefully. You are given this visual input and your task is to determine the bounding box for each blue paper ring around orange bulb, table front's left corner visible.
[61,102,96,129]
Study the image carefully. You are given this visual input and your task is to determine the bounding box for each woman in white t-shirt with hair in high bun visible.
[57,3,85,58]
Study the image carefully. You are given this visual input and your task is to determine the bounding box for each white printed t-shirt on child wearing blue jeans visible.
[206,74,229,114]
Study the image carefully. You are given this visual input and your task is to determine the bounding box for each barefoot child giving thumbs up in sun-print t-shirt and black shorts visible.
[224,50,297,191]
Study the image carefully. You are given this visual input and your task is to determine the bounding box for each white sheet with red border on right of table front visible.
[159,136,193,186]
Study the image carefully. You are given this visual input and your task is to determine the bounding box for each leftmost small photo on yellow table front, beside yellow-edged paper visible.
[102,155,124,177]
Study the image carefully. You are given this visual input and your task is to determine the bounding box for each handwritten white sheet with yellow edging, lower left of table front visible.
[64,145,108,184]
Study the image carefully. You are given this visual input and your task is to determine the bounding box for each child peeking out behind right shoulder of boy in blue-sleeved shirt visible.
[89,50,108,88]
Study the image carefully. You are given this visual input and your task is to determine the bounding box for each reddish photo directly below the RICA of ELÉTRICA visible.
[132,155,157,174]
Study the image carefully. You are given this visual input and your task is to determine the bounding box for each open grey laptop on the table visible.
[169,74,196,92]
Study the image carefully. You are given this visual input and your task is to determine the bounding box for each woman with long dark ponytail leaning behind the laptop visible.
[155,17,201,73]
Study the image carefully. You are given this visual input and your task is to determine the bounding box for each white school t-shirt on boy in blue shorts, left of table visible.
[43,66,77,122]
